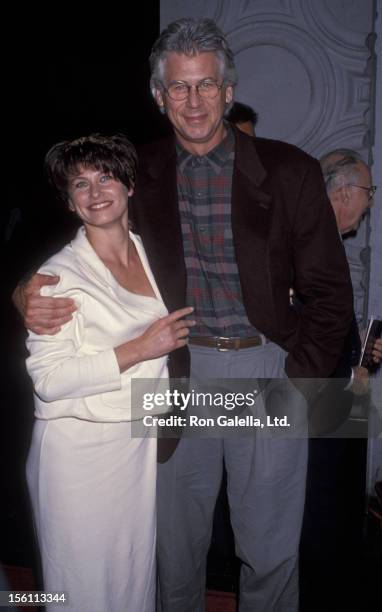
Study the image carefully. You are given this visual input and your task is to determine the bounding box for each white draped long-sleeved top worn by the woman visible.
[27,227,168,422]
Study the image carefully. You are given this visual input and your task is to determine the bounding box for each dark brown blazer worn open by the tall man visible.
[131,129,353,378]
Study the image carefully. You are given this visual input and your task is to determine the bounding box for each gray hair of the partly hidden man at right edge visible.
[320,149,365,193]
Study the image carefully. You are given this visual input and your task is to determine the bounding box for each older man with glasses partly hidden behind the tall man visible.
[300,149,382,612]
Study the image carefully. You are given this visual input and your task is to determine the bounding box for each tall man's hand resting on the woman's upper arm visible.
[13,274,76,335]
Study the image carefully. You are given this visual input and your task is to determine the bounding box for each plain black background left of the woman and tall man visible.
[0,0,175,568]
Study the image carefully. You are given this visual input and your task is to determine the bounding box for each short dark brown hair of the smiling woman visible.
[45,134,137,201]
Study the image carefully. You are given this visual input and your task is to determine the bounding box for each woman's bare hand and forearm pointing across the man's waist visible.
[114,307,195,372]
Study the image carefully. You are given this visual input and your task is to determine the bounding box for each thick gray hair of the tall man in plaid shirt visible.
[150,17,237,105]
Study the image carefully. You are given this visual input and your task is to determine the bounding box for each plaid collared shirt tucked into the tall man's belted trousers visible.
[177,126,258,337]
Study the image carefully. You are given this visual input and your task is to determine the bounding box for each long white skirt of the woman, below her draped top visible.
[27,418,157,612]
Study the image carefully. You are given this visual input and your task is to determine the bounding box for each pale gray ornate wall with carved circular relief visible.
[161,0,375,321]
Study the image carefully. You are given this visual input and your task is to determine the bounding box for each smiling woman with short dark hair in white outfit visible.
[27,134,193,612]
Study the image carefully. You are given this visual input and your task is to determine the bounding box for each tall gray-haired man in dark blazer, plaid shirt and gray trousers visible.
[14,18,352,612]
